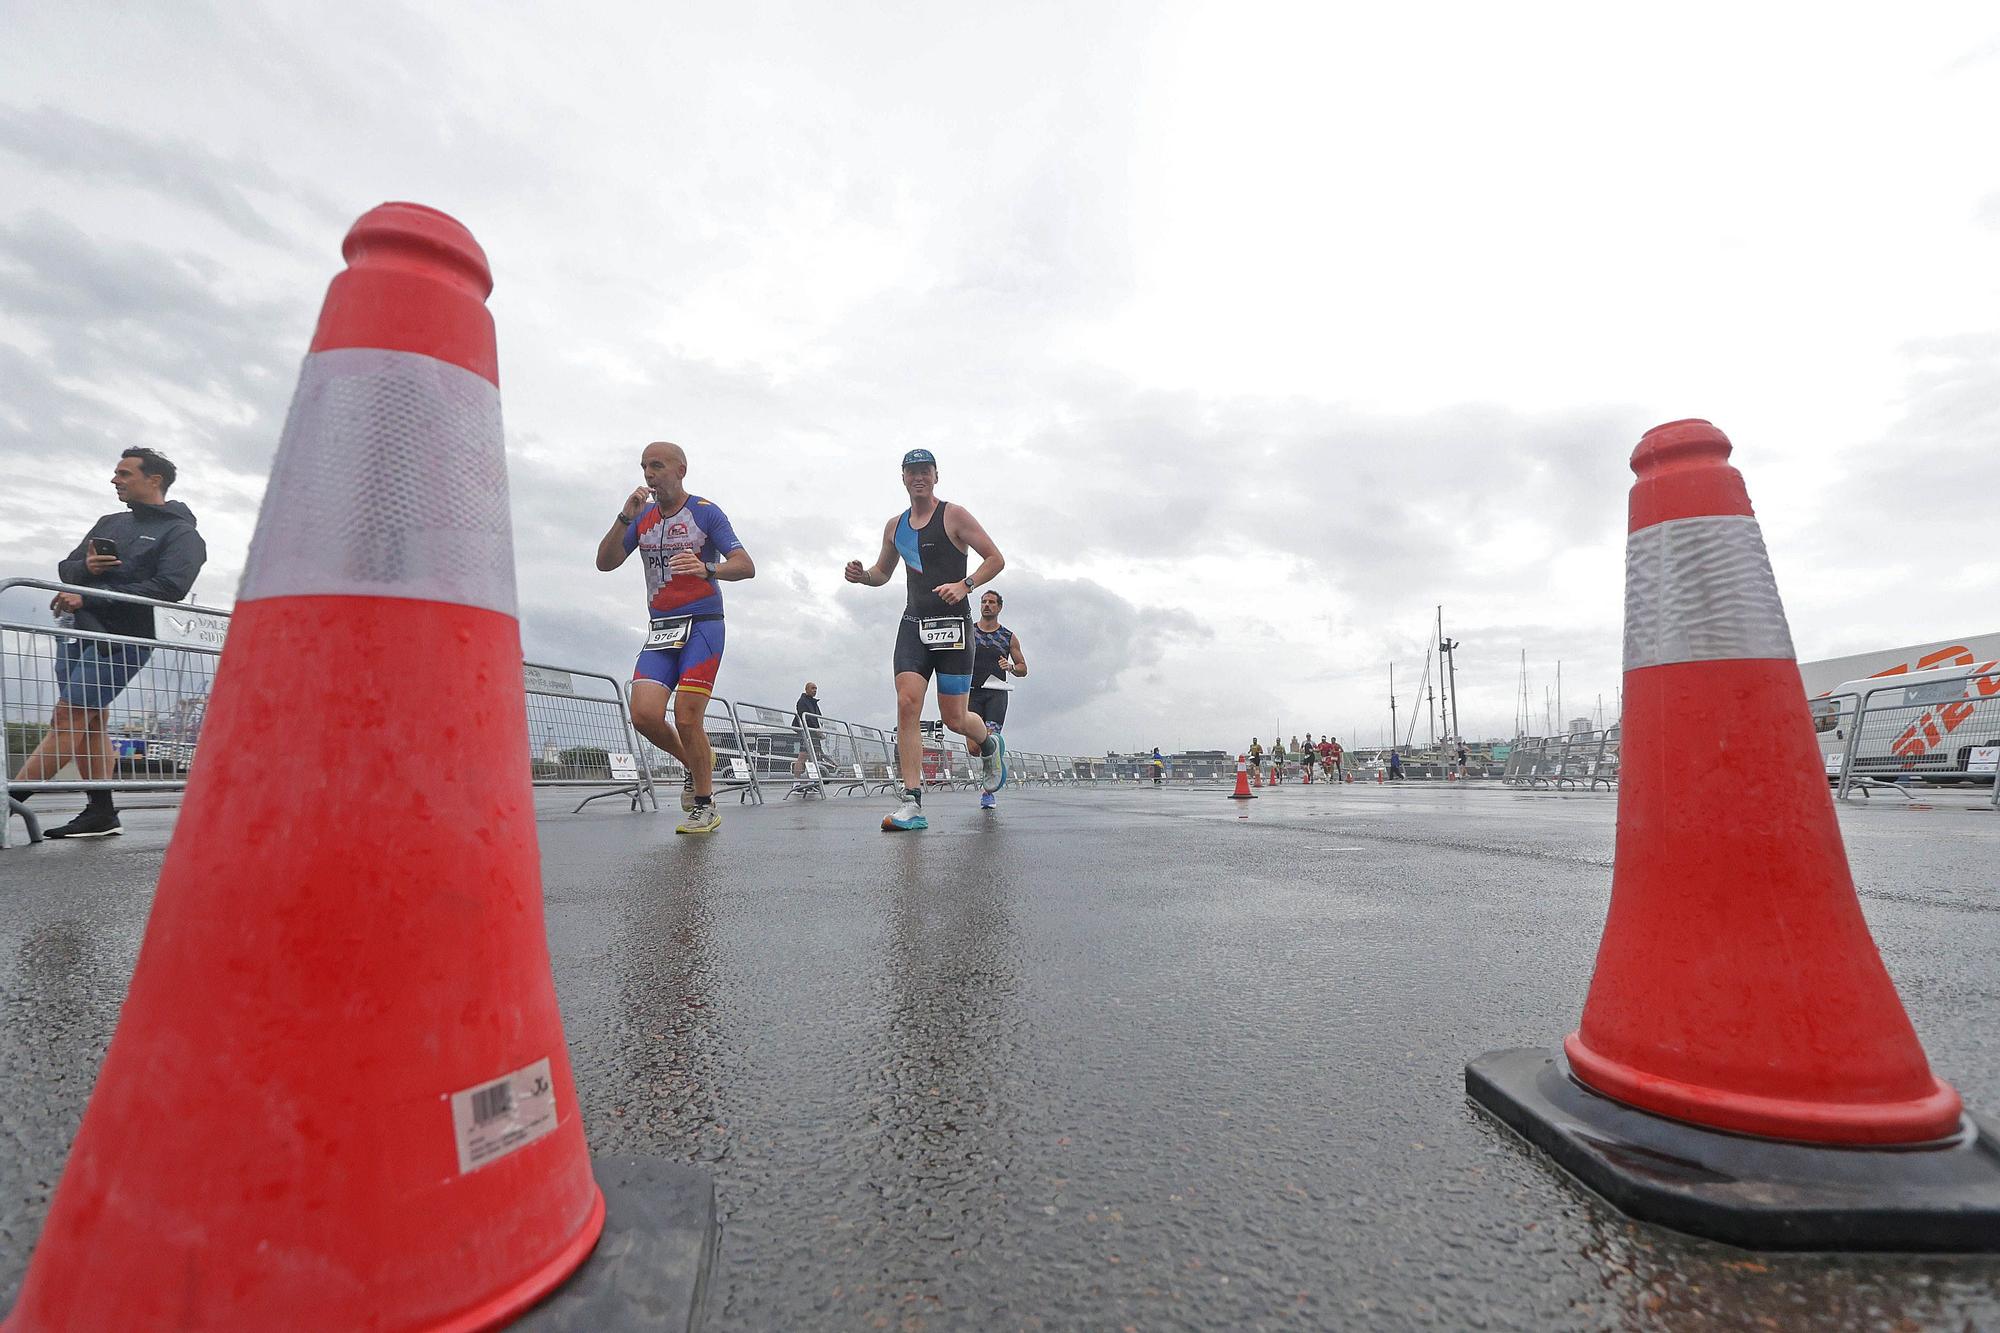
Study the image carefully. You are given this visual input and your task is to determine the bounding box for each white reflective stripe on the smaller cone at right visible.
[1624,514,1794,671]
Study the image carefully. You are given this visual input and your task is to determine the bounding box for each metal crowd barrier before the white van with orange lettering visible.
[1828,664,2000,811]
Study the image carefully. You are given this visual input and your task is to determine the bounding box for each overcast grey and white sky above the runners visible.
[0,0,2000,753]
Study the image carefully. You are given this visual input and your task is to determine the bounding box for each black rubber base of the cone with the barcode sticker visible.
[514,1157,716,1333]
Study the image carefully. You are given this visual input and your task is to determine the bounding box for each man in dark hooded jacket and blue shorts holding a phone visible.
[8,448,208,839]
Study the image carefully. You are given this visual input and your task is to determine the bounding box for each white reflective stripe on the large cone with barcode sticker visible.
[236,348,516,616]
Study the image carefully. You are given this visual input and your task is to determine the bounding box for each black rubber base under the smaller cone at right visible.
[1466,1047,2000,1253]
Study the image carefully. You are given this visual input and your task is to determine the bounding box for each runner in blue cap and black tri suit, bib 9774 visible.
[846,448,1006,833]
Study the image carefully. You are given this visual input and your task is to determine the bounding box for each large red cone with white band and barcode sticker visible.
[6,204,712,1333]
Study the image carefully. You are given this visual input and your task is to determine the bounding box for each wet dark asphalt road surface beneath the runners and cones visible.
[0,787,2000,1329]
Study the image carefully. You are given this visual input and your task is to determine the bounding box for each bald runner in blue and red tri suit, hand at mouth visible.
[598,440,756,833]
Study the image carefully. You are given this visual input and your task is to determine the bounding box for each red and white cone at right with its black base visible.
[1466,420,2000,1251]
